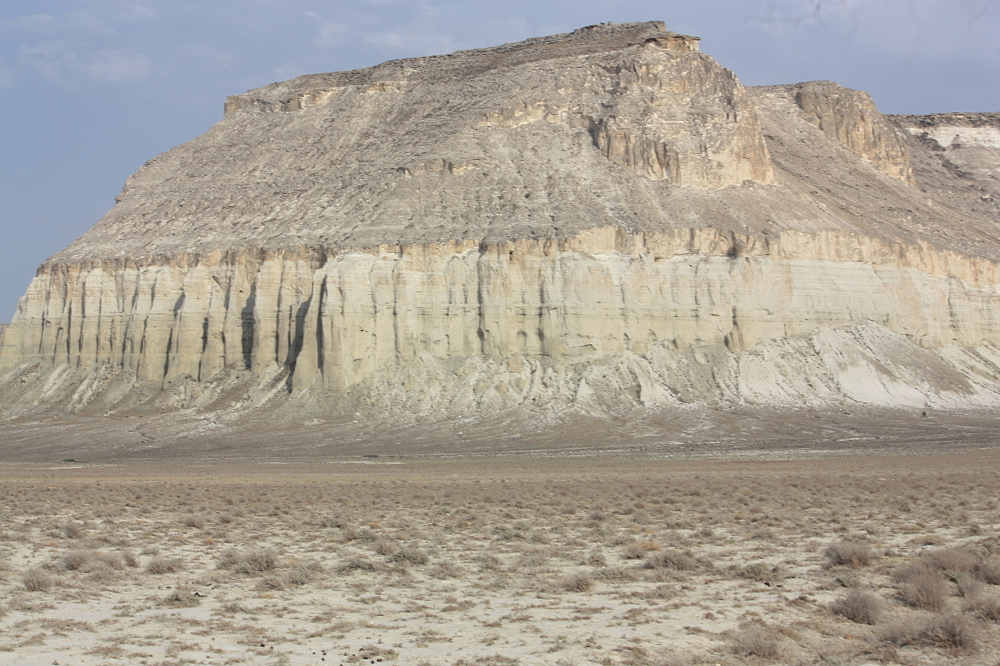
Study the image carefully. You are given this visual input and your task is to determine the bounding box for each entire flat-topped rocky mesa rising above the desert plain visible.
[0,22,1000,415]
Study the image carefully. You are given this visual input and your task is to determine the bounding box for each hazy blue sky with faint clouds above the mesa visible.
[0,0,1000,321]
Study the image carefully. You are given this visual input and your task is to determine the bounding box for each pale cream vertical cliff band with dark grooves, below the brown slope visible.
[0,227,1000,408]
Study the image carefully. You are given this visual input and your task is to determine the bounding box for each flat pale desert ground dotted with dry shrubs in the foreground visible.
[0,436,1000,666]
